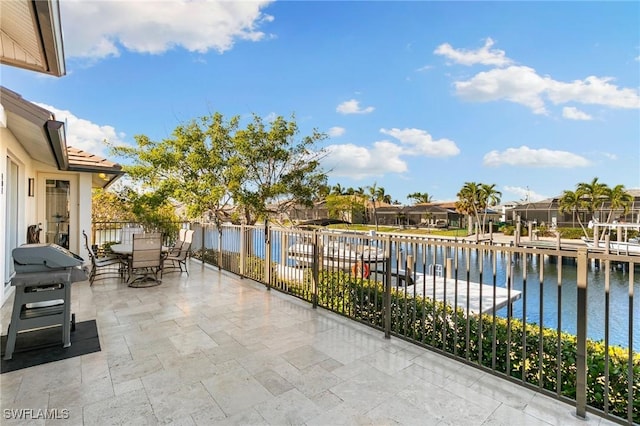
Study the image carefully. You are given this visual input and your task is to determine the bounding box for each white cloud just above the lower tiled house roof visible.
[34,102,125,158]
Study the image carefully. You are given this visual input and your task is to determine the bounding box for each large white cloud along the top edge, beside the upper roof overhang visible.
[60,0,273,59]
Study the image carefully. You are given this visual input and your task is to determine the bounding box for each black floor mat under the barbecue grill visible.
[1,320,100,373]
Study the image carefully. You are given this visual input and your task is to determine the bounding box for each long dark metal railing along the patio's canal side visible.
[89,224,640,424]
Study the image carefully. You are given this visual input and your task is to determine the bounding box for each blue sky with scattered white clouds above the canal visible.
[0,0,640,203]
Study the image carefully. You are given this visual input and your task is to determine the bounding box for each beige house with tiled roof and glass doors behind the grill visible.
[0,0,123,303]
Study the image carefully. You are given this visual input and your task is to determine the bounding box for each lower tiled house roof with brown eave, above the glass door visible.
[0,86,124,188]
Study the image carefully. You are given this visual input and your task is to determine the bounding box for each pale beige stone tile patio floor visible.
[0,262,613,425]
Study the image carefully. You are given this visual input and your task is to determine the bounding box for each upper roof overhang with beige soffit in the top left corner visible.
[0,0,66,77]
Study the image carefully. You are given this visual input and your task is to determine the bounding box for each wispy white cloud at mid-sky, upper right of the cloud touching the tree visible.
[380,128,460,157]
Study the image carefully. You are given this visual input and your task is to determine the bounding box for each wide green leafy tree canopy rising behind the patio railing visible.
[112,113,326,225]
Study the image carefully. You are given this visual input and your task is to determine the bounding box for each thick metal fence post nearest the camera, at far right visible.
[576,248,589,418]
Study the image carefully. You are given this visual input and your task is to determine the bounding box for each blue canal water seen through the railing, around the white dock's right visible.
[392,241,640,352]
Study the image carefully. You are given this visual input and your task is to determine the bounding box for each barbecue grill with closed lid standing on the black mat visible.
[4,244,88,360]
